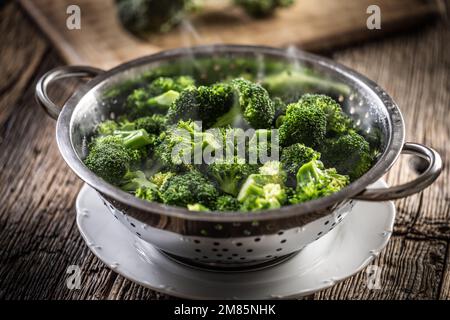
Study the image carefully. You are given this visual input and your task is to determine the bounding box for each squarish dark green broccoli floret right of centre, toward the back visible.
[278,99,327,148]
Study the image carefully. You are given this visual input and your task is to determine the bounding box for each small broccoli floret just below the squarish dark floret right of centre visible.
[280,143,320,176]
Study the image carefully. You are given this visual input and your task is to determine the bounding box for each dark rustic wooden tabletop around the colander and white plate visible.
[0,1,450,299]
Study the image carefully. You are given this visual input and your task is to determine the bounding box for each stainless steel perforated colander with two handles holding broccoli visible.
[36,45,442,270]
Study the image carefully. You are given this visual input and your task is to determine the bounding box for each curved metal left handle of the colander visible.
[35,66,104,119]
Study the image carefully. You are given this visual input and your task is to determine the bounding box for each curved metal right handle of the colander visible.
[353,142,442,201]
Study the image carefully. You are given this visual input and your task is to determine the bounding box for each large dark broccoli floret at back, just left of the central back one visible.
[167,83,234,129]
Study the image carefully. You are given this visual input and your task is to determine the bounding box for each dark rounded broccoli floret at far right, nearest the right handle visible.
[321,131,373,181]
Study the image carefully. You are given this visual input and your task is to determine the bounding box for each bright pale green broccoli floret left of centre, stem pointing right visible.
[155,120,222,171]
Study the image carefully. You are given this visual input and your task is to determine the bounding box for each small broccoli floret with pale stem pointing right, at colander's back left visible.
[126,88,180,118]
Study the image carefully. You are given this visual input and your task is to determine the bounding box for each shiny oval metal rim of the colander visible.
[56,45,404,222]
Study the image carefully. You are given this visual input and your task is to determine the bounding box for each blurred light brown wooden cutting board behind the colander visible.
[20,0,437,68]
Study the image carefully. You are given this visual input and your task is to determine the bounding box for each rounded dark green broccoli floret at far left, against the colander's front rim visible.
[84,136,132,184]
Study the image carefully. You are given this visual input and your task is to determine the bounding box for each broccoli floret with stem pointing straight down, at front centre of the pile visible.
[208,157,258,196]
